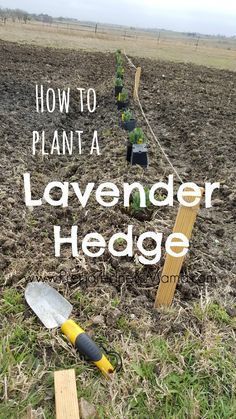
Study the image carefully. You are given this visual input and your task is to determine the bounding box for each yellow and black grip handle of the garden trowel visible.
[61,319,115,378]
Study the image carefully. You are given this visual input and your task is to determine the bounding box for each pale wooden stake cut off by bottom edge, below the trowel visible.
[54,369,80,419]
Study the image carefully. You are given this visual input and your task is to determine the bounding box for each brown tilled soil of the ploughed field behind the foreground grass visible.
[0,42,236,308]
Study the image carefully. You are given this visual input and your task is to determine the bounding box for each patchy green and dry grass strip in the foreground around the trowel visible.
[0,289,236,419]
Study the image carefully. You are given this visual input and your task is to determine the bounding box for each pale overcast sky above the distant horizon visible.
[0,0,236,36]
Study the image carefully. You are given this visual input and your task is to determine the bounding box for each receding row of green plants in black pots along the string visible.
[115,50,148,167]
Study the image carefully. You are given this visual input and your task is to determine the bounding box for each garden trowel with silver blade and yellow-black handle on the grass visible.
[25,282,115,378]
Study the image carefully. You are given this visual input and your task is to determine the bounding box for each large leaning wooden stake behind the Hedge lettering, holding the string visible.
[155,188,204,308]
